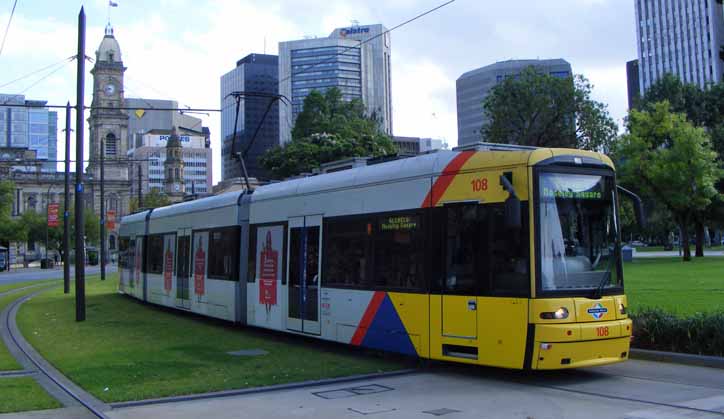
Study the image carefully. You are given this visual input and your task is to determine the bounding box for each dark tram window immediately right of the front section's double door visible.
[322,217,372,288]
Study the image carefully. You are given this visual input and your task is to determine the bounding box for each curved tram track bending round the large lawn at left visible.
[3,285,108,419]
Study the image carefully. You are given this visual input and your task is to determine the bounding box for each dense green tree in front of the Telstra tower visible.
[261,88,397,178]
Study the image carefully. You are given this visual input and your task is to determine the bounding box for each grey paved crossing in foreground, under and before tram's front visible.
[102,360,724,419]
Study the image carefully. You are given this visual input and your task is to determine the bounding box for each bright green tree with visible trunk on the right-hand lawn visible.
[618,101,722,261]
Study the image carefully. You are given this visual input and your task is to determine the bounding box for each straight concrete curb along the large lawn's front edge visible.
[109,369,419,409]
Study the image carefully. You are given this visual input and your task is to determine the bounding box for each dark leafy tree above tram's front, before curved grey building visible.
[481,66,618,153]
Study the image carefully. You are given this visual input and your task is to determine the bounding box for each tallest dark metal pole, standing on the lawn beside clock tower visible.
[75,6,85,322]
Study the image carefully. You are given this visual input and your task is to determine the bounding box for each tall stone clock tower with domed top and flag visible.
[86,24,129,181]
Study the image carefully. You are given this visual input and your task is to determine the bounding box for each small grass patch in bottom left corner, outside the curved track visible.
[0,377,62,413]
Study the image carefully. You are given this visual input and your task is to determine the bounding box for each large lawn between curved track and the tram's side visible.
[18,274,407,402]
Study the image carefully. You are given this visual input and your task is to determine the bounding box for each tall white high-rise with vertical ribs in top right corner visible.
[634,0,724,94]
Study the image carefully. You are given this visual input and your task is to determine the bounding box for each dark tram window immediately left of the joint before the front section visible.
[208,227,239,281]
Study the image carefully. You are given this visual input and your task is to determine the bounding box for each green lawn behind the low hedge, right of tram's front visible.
[624,257,724,315]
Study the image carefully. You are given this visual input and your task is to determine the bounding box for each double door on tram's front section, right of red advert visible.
[287,215,322,335]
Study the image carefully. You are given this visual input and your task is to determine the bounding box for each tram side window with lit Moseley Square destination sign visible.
[374,213,425,290]
